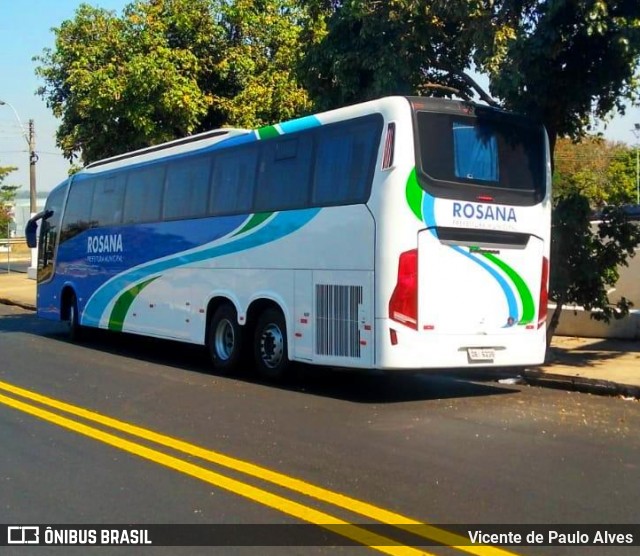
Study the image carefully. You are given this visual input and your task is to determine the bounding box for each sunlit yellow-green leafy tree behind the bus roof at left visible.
[36,0,316,163]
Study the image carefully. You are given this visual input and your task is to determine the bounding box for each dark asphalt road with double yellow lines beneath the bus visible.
[0,305,640,555]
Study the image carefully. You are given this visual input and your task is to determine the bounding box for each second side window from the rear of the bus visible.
[255,133,313,212]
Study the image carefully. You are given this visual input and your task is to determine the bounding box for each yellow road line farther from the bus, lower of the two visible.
[0,394,429,556]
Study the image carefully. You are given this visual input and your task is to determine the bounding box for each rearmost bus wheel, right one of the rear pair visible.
[253,308,291,382]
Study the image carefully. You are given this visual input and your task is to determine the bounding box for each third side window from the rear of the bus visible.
[209,146,258,215]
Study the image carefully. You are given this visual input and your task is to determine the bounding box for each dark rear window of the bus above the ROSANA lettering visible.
[416,111,545,204]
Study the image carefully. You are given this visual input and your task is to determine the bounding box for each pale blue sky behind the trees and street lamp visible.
[0,0,640,195]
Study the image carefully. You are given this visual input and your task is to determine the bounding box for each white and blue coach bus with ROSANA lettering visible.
[27,97,551,379]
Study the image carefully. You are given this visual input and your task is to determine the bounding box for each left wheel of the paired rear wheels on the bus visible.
[207,303,243,373]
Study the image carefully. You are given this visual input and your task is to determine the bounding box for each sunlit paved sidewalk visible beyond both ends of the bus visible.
[0,270,640,398]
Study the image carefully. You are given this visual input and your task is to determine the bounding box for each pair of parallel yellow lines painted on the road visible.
[0,381,514,556]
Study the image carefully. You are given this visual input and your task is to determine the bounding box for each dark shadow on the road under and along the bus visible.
[10,315,520,404]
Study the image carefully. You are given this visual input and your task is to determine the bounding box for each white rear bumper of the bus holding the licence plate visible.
[375,319,546,370]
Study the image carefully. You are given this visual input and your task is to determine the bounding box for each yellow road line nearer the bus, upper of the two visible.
[0,381,515,556]
